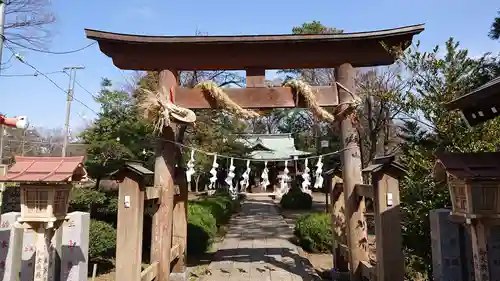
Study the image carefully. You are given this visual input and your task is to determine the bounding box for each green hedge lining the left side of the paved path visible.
[187,193,239,254]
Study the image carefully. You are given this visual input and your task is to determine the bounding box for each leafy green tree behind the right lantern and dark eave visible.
[400,39,500,278]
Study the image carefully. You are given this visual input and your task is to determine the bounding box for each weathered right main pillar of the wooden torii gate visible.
[335,63,368,281]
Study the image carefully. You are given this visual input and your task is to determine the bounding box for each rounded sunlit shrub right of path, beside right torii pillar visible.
[294,213,333,253]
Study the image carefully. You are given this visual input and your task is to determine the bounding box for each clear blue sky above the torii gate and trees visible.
[0,0,500,129]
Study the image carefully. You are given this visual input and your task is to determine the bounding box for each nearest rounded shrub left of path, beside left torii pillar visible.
[187,203,217,254]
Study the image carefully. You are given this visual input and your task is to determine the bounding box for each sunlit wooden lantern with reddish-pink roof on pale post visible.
[0,157,87,281]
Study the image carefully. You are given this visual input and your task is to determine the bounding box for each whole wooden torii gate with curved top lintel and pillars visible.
[85,25,424,280]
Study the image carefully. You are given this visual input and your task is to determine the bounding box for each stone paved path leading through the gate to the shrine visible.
[203,197,320,281]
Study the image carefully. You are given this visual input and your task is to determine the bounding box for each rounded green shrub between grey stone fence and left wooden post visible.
[89,220,116,261]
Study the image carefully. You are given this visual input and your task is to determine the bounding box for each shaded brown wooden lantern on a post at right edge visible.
[434,152,500,281]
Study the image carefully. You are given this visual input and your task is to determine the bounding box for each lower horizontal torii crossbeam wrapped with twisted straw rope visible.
[175,86,339,109]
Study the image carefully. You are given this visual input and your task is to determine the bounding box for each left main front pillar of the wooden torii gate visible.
[151,70,177,281]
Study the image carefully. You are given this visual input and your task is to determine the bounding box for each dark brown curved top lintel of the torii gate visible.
[85,24,424,71]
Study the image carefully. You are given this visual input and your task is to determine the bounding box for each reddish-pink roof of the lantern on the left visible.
[0,156,86,182]
